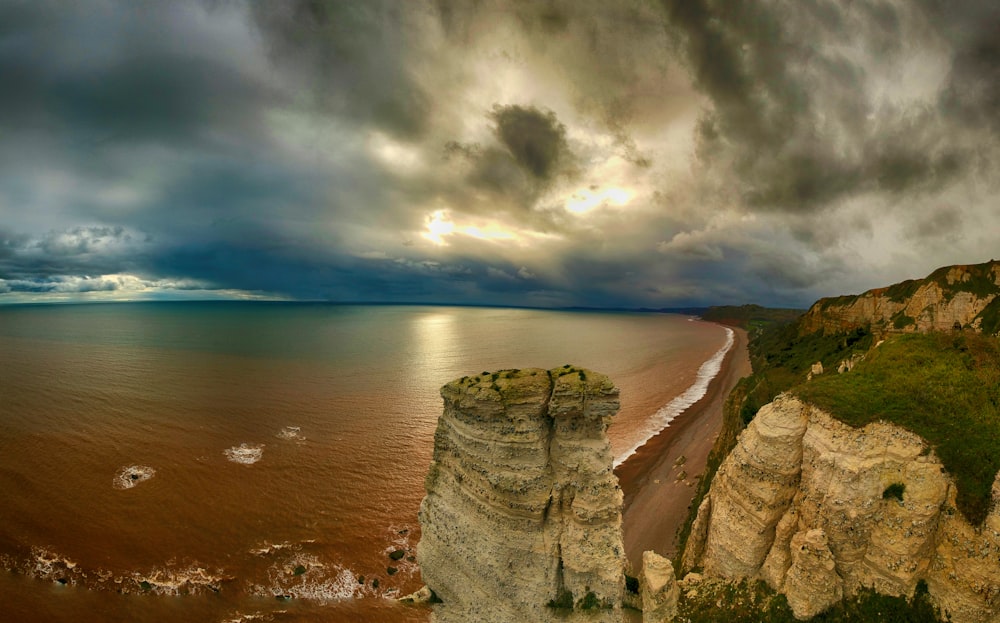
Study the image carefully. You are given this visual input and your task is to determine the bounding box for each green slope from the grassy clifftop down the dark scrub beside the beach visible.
[678,324,1000,572]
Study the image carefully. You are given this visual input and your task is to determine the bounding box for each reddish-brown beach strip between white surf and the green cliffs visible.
[615,328,750,570]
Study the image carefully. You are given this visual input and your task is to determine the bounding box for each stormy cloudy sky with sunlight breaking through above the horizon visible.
[0,0,1000,308]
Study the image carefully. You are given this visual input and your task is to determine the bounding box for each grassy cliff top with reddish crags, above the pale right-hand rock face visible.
[739,260,1000,524]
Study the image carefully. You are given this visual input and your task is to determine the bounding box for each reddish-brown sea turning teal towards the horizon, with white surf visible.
[0,302,732,623]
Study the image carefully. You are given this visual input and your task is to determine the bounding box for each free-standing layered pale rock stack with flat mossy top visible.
[417,367,625,621]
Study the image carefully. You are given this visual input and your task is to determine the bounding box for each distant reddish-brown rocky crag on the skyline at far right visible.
[799,261,1000,335]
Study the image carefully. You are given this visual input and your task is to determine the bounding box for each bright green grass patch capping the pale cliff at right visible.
[792,332,1000,525]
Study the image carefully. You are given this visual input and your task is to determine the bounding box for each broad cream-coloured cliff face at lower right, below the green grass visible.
[684,396,1000,623]
